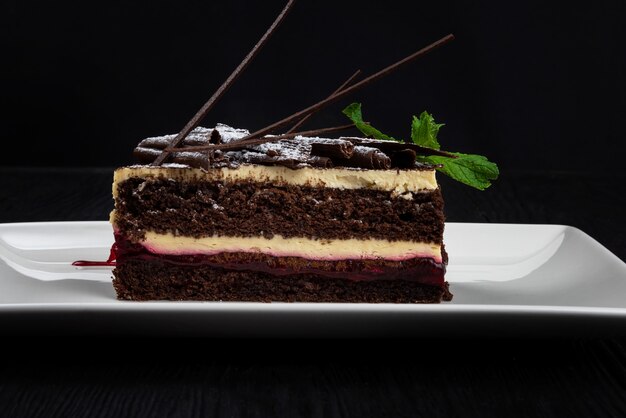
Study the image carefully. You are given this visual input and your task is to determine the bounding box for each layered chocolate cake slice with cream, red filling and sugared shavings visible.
[111,125,452,303]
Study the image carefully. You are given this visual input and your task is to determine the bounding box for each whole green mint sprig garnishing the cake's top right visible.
[343,103,500,190]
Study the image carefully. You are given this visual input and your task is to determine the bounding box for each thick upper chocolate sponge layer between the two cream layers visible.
[115,178,444,244]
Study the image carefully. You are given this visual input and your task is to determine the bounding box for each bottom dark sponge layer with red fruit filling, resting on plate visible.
[113,258,452,303]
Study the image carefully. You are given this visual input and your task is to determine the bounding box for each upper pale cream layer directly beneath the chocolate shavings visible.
[113,164,438,197]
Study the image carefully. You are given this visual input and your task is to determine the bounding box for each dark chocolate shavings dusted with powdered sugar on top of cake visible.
[133,124,435,170]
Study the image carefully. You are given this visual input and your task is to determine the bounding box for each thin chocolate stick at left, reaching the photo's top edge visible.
[152,0,295,165]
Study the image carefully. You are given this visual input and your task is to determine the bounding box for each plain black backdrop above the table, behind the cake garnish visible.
[0,0,626,171]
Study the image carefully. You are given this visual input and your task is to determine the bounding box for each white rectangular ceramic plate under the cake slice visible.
[0,222,626,337]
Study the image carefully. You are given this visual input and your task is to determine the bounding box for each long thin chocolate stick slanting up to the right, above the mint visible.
[234,34,454,141]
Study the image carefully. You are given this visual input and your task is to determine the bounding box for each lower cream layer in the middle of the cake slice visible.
[142,231,441,263]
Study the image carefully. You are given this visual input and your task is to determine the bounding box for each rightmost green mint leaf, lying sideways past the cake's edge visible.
[419,152,500,190]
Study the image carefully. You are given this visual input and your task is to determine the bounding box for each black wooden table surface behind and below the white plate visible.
[0,168,626,417]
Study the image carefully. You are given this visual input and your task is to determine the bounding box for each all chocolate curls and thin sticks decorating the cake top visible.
[139,0,454,169]
